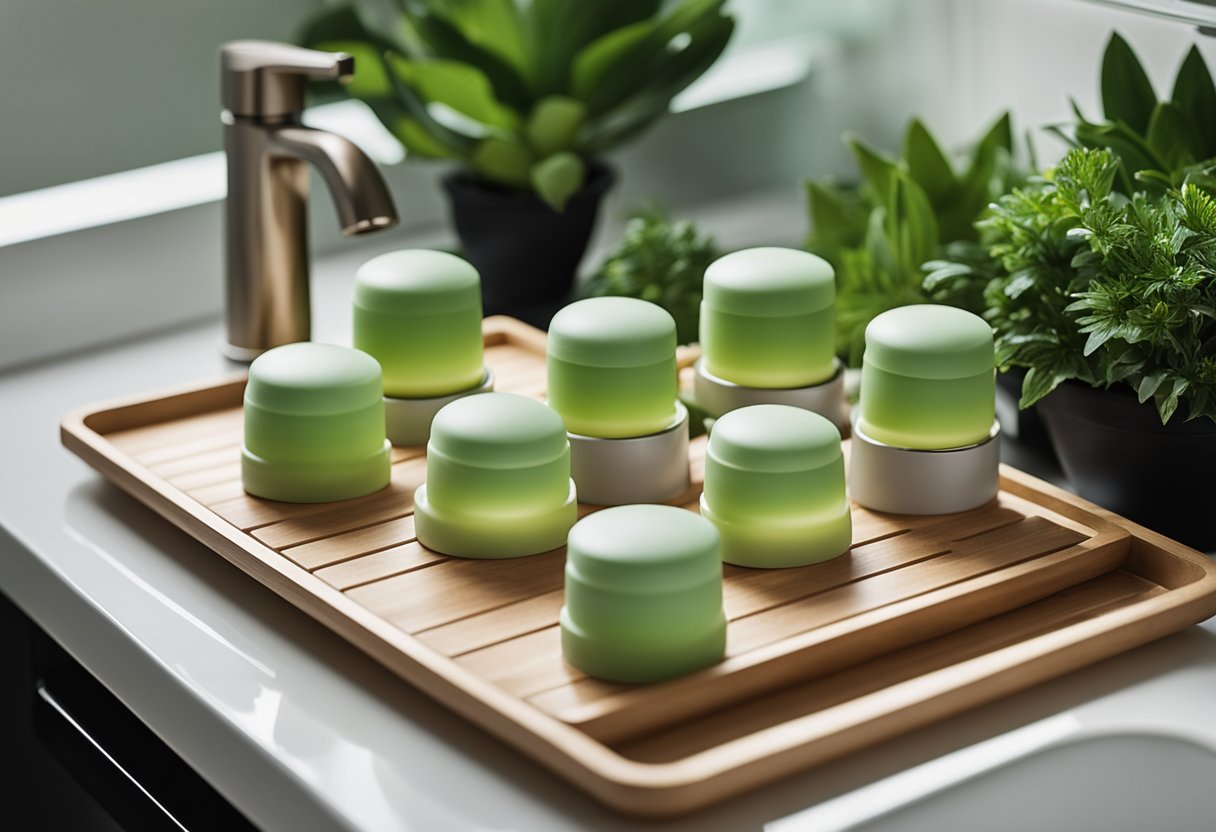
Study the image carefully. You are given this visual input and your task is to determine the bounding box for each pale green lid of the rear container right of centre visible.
[704,247,835,317]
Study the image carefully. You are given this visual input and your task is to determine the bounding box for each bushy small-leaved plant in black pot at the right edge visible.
[929,148,1216,546]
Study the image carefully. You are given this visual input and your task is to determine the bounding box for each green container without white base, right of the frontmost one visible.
[700,405,852,568]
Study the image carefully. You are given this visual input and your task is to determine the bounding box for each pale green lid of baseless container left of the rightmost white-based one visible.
[706,405,840,473]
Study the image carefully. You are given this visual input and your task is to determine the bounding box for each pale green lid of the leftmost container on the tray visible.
[244,341,384,416]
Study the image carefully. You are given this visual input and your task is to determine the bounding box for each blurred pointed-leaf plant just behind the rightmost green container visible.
[806,113,1019,366]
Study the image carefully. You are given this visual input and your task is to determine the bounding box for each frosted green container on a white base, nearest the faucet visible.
[354,249,485,399]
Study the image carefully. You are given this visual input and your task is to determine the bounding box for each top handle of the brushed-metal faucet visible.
[220,40,355,118]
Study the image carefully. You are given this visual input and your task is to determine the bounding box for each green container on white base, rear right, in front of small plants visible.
[700,248,837,388]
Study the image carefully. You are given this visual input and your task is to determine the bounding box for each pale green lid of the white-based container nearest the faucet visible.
[355,248,482,317]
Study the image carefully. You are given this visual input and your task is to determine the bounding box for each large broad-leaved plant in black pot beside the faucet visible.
[303,0,733,314]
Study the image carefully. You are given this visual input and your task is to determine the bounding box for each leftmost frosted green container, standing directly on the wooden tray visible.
[241,342,389,502]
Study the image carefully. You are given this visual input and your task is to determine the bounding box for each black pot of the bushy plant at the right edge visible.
[1038,382,1216,551]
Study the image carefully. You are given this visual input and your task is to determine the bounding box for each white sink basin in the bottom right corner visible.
[766,708,1216,832]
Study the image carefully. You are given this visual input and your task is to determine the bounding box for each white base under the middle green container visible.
[567,403,691,506]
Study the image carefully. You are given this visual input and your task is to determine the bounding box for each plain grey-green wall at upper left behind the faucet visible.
[0,0,321,196]
